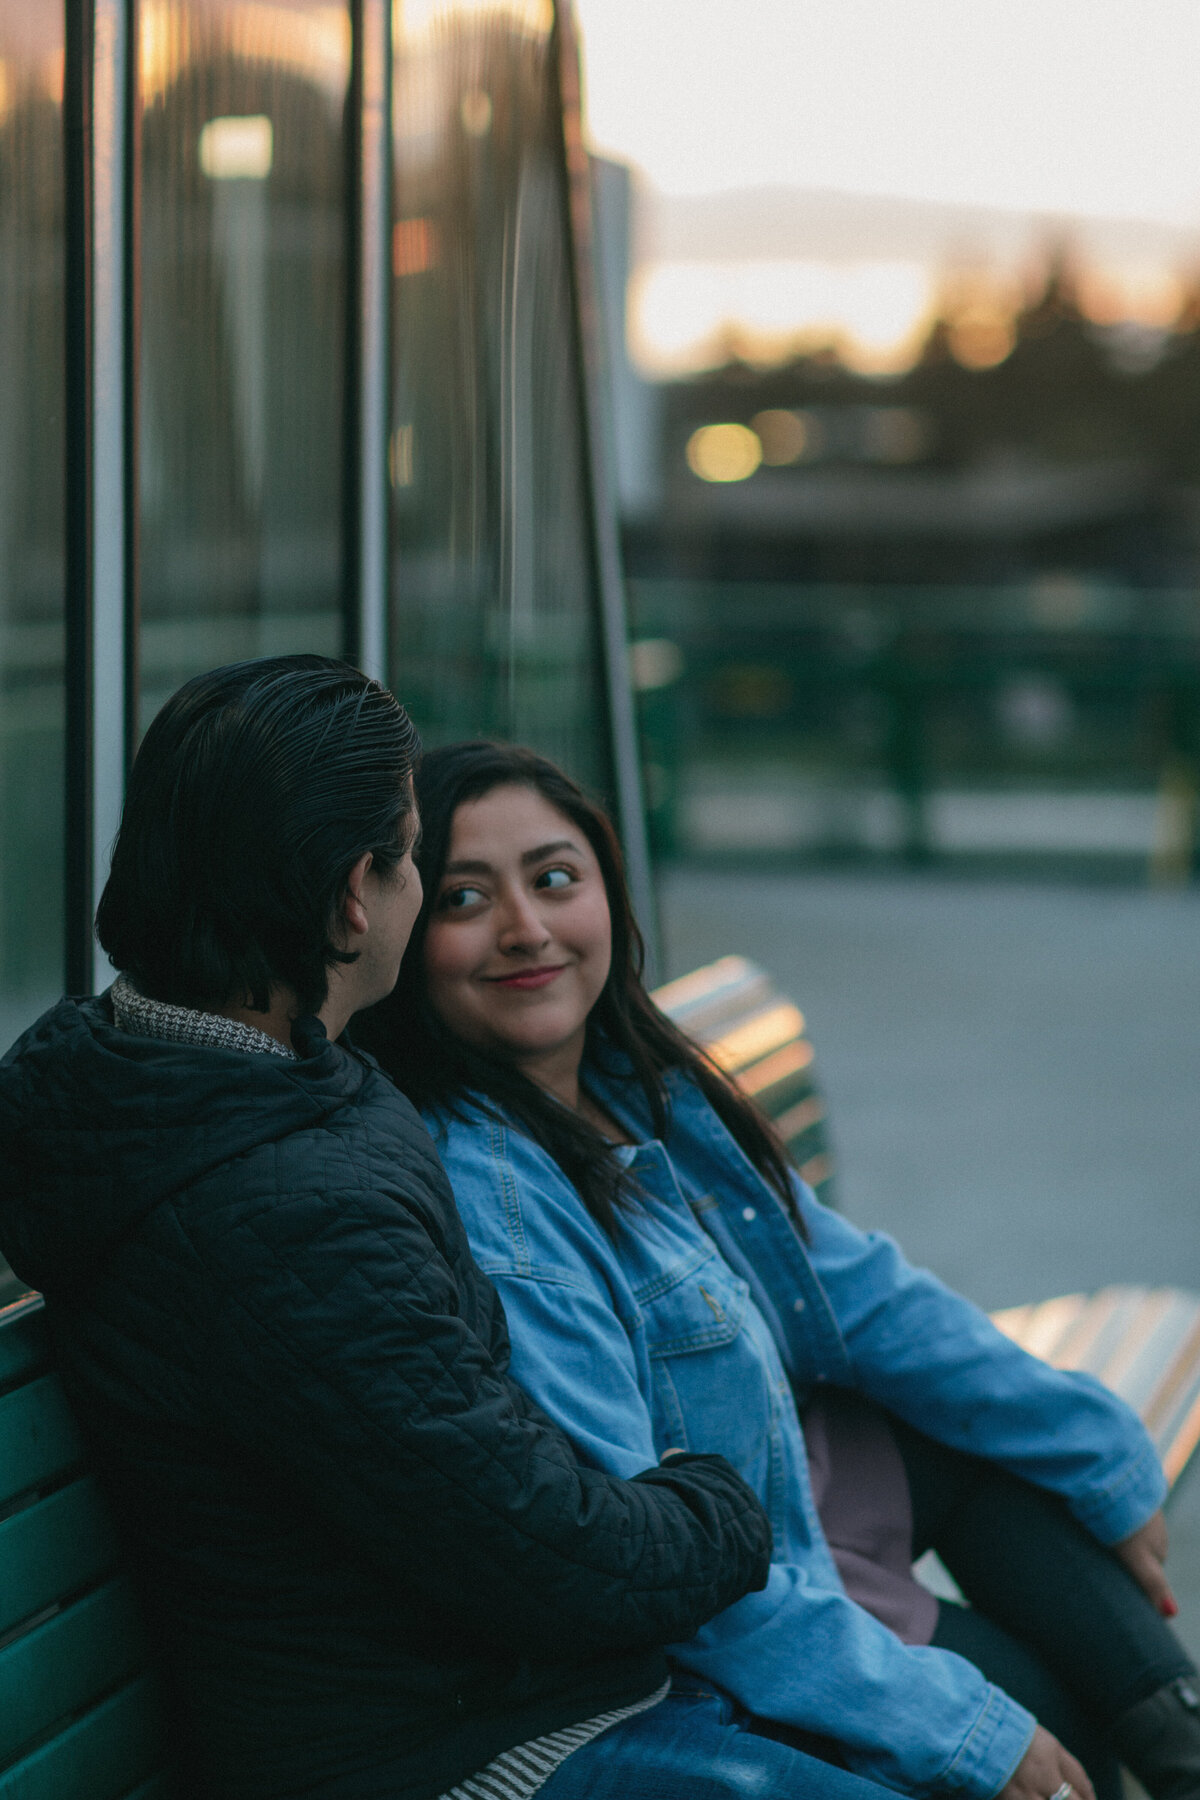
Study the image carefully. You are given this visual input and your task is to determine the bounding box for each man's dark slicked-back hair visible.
[95,655,421,1012]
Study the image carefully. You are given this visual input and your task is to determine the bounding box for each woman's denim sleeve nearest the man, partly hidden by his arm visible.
[439,1121,1034,1800]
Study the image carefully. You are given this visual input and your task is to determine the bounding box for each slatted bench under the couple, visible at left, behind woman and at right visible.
[0,956,1200,1800]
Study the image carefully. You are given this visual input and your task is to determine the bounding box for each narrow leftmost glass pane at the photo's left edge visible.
[0,0,65,1049]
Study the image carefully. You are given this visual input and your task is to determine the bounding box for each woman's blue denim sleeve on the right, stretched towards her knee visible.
[797,1184,1166,1544]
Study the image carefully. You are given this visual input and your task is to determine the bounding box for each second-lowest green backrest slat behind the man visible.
[0,1580,146,1768]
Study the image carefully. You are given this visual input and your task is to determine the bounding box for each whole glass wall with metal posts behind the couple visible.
[0,0,646,1048]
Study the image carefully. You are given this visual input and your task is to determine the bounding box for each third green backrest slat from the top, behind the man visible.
[0,1476,119,1636]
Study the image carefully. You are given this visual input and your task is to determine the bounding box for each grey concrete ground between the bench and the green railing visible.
[660,868,1200,1658]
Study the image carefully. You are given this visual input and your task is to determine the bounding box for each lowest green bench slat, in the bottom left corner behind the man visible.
[0,1676,166,1800]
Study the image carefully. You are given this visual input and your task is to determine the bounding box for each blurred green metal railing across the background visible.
[631,578,1200,878]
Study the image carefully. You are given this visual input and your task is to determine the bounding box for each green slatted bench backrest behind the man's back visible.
[0,1282,166,1800]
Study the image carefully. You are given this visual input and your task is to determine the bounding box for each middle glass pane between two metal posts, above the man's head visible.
[139,0,351,724]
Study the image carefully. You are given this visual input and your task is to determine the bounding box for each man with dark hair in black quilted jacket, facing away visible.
[0,657,773,1800]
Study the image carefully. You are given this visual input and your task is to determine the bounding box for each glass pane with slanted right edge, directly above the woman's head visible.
[390,0,608,788]
